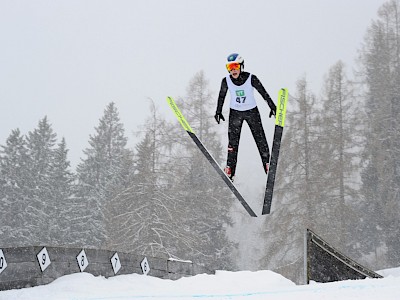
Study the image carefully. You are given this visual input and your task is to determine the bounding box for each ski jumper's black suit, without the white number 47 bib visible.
[216,72,276,177]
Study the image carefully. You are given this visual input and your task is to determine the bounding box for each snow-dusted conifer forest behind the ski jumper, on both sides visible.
[0,0,400,276]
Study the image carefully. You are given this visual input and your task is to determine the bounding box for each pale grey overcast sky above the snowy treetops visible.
[0,0,386,165]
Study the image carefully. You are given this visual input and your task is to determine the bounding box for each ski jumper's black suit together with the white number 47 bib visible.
[217,72,276,177]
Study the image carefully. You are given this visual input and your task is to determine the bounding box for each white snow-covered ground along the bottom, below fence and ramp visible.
[0,268,400,300]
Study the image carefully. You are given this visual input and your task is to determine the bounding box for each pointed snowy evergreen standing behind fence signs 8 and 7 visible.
[77,102,132,247]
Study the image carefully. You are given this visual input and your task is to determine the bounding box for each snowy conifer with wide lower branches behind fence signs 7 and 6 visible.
[107,101,176,257]
